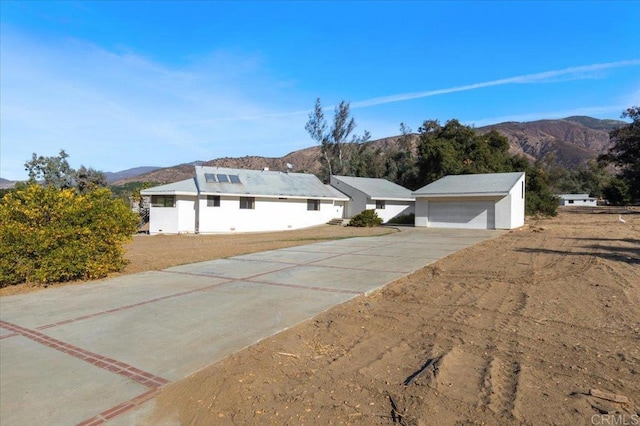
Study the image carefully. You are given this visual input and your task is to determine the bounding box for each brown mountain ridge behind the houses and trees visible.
[114,116,627,185]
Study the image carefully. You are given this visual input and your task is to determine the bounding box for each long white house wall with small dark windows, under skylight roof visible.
[198,195,343,233]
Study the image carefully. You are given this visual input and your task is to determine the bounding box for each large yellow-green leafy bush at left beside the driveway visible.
[0,184,138,287]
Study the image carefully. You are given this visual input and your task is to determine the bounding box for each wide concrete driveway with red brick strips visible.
[0,228,502,426]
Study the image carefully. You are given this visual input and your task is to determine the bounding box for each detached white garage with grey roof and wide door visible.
[413,172,525,229]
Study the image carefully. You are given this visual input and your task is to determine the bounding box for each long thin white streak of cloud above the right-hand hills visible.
[351,59,640,108]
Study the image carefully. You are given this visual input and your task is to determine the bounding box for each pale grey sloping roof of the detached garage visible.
[413,172,524,197]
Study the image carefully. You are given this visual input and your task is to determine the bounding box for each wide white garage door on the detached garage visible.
[428,201,496,229]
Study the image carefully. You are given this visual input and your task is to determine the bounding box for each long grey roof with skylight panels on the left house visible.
[195,166,348,200]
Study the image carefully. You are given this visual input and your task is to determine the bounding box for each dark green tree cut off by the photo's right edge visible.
[598,106,640,200]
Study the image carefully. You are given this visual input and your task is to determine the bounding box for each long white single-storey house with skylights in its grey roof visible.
[141,166,349,234]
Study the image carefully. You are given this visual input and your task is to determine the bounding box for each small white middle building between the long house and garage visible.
[330,176,415,222]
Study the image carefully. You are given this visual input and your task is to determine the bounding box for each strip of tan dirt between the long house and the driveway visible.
[0,225,396,297]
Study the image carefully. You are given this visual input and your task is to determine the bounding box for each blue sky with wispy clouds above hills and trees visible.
[0,0,640,180]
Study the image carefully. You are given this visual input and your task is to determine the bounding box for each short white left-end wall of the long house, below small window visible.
[149,195,196,234]
